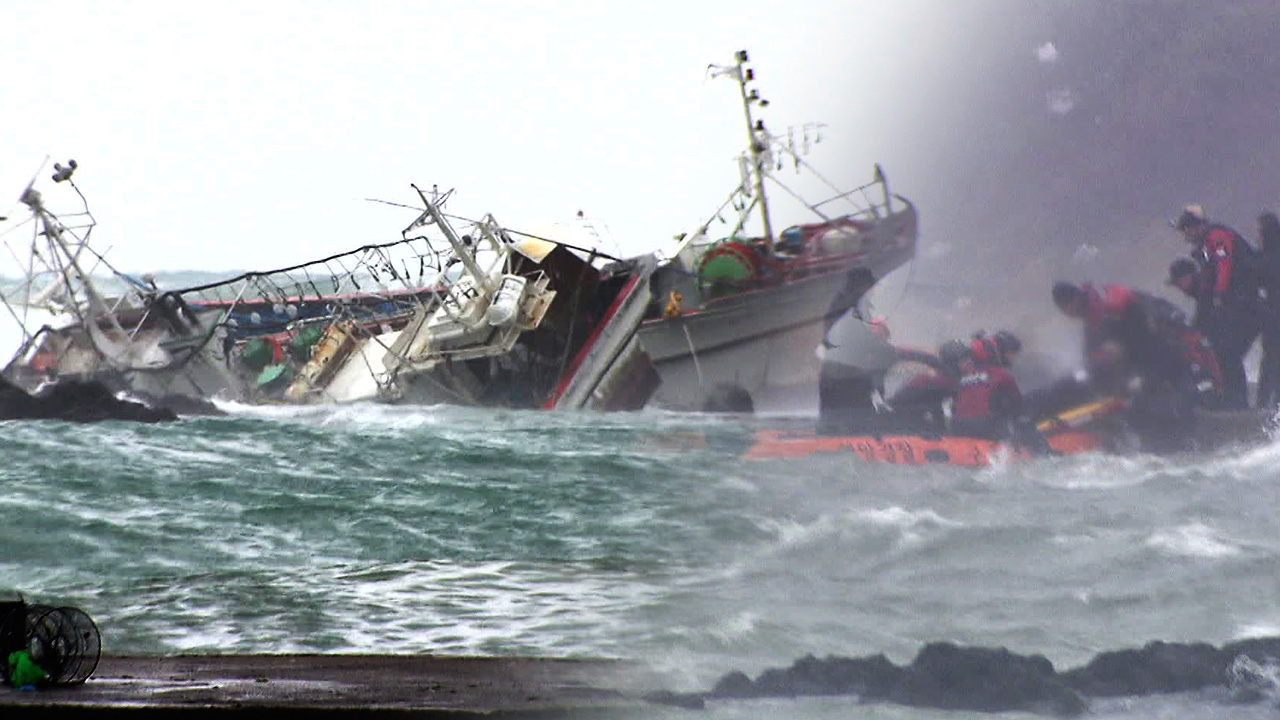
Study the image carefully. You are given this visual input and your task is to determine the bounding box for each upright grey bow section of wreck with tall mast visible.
[640,51,918,413]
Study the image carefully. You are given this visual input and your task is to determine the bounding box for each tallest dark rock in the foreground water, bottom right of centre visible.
[890,643,1088,716]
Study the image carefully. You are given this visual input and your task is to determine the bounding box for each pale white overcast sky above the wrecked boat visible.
[0,0,962,272]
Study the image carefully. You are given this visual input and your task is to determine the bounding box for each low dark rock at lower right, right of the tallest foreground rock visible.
[1062,641,1233,697]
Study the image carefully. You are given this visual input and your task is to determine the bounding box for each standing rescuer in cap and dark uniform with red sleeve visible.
[1172,205,1262,407]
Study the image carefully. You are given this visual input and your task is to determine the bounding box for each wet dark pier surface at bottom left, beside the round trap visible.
[0,655,657,720]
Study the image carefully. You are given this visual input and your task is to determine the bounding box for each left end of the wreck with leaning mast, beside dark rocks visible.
[0,160,249,397]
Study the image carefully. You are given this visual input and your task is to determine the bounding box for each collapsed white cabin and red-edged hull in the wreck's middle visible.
[295,184,658,410]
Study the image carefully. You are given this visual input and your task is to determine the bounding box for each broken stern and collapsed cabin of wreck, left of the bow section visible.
[3,163,658,410]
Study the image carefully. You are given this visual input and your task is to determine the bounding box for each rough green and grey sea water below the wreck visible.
[0,397,1280,720]
